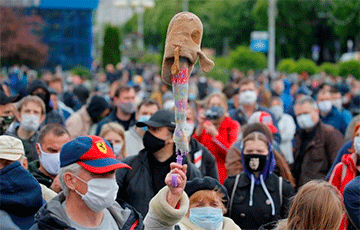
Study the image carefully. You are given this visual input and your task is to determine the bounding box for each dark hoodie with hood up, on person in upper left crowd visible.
[28,79,65,125]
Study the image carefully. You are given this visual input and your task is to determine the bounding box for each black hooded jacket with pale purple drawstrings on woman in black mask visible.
[224,173,295,229]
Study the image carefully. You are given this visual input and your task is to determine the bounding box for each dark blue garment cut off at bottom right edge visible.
[344,176,360,229]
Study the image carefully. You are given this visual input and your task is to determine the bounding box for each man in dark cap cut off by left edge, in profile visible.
[0,89,19,135]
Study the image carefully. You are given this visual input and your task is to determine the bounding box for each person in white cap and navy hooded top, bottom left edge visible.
[0,135,43,229]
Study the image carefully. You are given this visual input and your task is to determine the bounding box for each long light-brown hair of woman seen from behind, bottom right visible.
[277,180,344,230]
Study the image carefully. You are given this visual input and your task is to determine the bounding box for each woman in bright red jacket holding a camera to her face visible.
[193,93,240,184]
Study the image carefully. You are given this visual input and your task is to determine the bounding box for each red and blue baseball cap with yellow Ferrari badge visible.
[60,136,131,174]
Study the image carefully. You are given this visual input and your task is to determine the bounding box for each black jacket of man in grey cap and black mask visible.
[116,149,202,216]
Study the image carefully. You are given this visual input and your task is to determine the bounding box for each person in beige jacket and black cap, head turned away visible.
[66,95,110,139]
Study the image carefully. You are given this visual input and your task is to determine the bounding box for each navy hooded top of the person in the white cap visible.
[0,162,43,229]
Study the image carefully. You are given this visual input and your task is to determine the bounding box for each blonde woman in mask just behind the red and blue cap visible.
[100,122,127,160]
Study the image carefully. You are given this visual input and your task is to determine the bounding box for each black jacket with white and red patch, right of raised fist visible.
[187,138,219,180]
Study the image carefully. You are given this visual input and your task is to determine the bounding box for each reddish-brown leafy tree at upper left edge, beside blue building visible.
[0,7,48,68]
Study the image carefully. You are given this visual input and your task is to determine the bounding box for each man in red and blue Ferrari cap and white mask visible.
[31,136,143,230]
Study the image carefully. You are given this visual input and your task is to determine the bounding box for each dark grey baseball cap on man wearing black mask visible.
[136,109,175,128]
